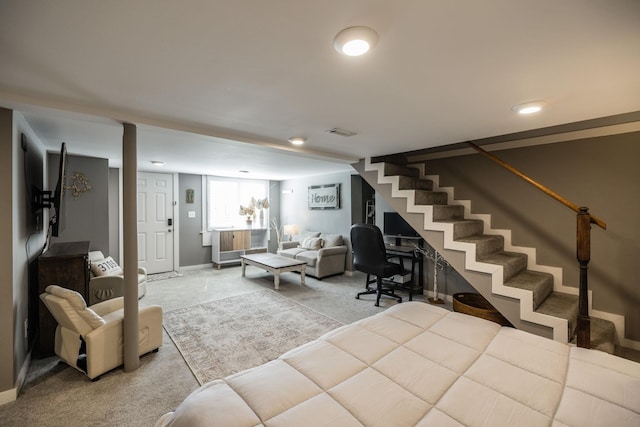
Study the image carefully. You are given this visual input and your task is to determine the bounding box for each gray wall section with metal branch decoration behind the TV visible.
[47,154,110,254]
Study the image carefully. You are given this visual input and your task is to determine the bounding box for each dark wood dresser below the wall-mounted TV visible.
[36,242,89,357]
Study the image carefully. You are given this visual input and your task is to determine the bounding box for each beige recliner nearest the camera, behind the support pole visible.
[40,285,162,380]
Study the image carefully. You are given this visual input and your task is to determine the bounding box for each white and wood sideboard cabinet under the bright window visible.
[211,228,269,268]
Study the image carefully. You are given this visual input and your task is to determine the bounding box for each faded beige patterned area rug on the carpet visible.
[163,290,342,384]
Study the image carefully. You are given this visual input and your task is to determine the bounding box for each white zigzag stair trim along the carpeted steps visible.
[365,158,569,343]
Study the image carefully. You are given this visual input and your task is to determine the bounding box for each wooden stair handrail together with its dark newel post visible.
[468,142,607,348]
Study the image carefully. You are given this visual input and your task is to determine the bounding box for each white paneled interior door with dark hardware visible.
[138,172,174,274]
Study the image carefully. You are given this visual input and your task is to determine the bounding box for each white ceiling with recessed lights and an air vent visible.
[0,0,640,179]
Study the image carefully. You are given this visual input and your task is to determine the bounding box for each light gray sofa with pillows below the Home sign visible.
[277,231,349,279]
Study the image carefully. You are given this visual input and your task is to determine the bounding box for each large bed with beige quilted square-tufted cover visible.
[156,302,640,427]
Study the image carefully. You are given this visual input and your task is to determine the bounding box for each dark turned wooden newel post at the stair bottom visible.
[577,207,591,348]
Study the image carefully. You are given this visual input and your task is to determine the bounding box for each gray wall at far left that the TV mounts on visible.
[0,108,48,403]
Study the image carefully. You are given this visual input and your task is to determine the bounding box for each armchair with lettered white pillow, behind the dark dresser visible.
[89,251,147,305]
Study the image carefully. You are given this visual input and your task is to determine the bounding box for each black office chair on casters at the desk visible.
[351,224,403,306]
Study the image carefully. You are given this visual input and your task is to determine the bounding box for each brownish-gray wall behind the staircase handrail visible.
[420,133,640,340]
